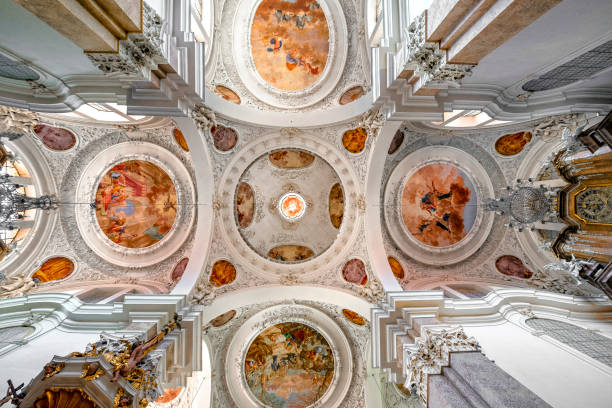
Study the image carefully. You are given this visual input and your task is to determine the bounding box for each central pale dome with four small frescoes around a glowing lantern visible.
[234,149,344,263]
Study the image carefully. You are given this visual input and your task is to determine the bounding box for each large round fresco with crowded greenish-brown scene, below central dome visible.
[244,322,334,408]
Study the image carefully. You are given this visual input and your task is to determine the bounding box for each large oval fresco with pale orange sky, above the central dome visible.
[251,0,329,91]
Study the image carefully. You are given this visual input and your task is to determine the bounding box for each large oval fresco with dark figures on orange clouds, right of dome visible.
[401,164,477,247]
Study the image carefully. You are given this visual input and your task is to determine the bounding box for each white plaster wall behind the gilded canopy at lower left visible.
[0,328,100,390]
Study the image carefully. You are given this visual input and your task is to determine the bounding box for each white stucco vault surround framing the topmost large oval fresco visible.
[212,0,370,111]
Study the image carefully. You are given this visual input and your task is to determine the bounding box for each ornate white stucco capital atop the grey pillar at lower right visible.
[404,327,480,404]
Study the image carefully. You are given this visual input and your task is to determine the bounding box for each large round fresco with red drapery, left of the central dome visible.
[96,160,177,248]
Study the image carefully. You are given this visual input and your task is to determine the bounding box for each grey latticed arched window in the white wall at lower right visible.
[525,318,612,367]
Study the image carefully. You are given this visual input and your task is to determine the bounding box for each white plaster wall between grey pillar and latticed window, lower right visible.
[464,321,612,408]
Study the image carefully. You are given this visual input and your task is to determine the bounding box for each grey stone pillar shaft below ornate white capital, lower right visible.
[428,351,550,408]
